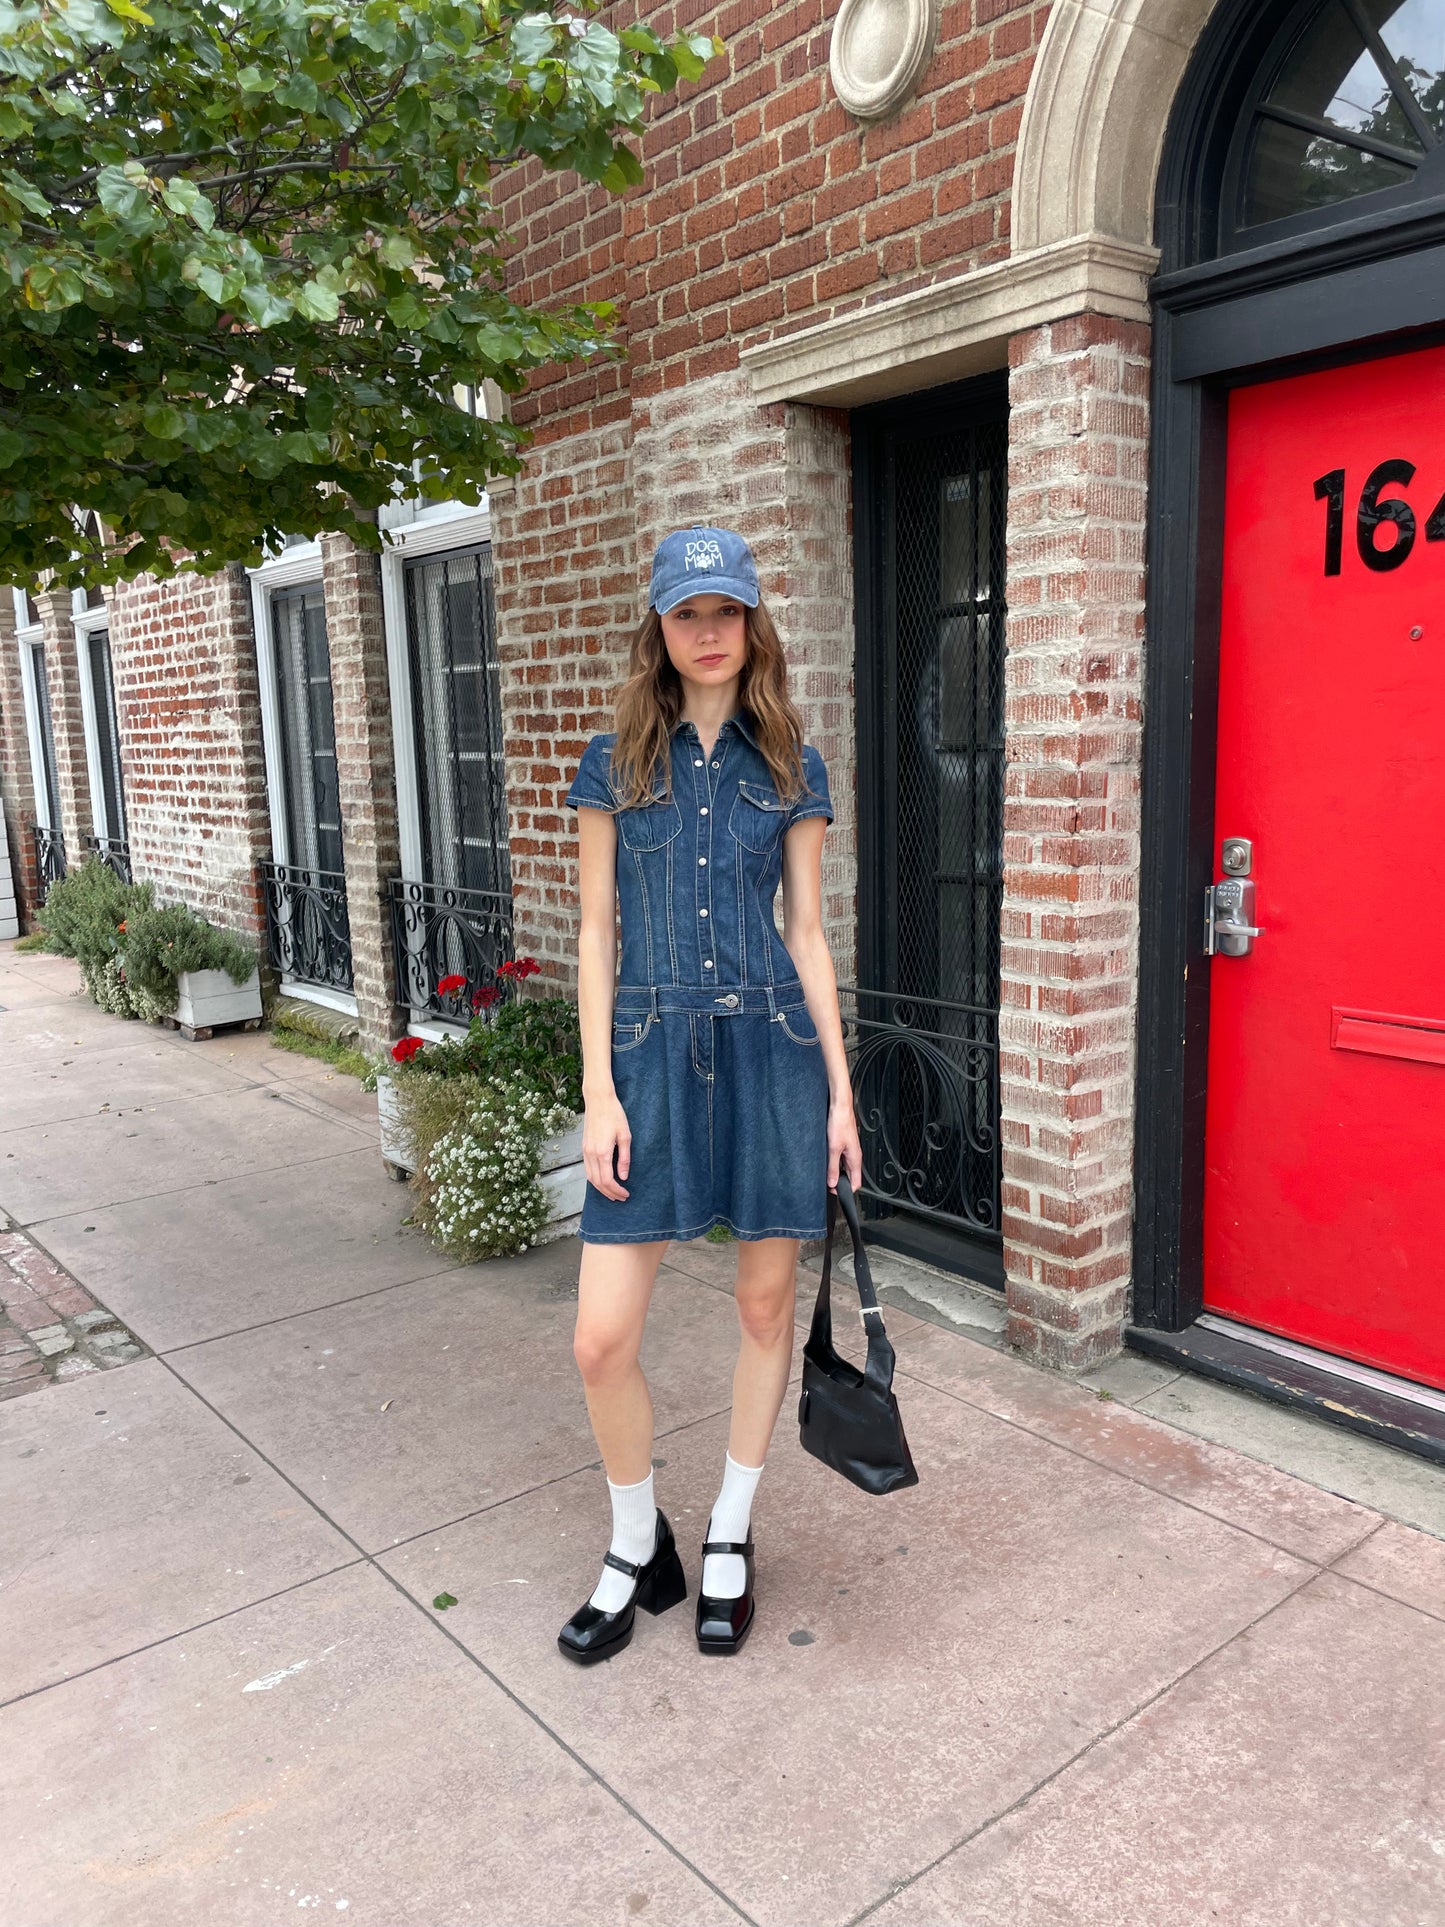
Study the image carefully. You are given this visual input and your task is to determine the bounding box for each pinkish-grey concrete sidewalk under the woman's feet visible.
[0,946,1445,1927]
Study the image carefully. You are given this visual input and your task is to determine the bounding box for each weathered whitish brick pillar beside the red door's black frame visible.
[1000,318,1148,1368]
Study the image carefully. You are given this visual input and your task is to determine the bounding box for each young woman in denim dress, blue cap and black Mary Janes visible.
[559,528,863,1665]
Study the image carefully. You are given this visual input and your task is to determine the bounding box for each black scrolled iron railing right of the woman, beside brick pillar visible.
[838,985,1002,1245]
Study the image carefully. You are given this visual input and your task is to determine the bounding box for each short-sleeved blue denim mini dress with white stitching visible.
[565,711,832,1245]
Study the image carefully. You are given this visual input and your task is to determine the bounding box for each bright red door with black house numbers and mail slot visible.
[1200,349,1445,1387]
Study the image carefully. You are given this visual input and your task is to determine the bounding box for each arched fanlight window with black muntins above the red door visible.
[1225,0,1445,247]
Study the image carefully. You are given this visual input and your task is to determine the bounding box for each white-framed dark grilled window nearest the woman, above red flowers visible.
[407,547,512,896]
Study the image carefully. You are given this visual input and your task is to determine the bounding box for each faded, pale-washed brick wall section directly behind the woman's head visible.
[491,372,855,985]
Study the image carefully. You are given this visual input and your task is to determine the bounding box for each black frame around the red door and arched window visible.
[1133,0,1445,1332]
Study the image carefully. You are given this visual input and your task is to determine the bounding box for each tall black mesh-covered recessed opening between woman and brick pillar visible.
[844,382,1008,1283]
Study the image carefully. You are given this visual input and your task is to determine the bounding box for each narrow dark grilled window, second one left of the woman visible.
[272,584,343,873]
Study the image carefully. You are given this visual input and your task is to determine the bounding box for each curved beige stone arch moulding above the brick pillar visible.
[1012,0,1220,254]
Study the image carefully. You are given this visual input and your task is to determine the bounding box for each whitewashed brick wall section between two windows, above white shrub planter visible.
[110,568,272,937]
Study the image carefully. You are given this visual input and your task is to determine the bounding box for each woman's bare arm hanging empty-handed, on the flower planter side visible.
[576,809,632,1199]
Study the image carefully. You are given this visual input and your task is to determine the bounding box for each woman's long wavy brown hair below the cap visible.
[613,601,805,809]
